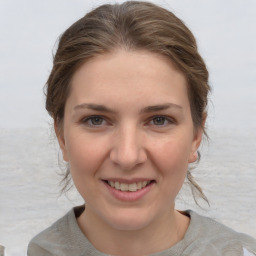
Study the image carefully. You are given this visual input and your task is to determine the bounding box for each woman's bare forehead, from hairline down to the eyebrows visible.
[70,50,188,112]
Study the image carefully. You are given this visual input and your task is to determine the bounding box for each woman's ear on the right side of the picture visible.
[188,112,207,163]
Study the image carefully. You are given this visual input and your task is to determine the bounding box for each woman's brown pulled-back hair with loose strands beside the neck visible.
[45,1,210,202]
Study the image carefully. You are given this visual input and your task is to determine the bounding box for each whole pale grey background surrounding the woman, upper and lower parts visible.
[0,0,256,256]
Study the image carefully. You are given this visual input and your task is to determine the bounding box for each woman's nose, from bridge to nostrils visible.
[110,125,147,170]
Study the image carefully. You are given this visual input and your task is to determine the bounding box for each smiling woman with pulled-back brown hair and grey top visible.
[28,1,256,256]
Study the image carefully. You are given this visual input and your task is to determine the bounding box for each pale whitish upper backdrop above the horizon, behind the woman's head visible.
[0,0,256,129]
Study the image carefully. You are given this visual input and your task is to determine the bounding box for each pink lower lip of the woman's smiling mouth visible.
[103,182,155,201]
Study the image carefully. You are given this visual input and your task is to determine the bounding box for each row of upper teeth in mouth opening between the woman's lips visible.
[104,180,155,192]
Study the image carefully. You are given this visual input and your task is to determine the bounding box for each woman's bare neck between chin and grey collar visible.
[78,206,189,256]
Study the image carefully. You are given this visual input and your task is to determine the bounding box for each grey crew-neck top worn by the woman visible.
[28,206,256,256]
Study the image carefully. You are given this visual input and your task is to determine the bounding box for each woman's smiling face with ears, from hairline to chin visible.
[58,50,202,230]
